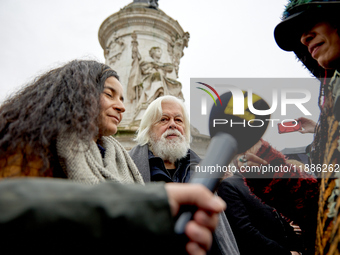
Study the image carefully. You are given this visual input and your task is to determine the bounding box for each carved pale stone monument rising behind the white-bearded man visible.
[98,0,210,155]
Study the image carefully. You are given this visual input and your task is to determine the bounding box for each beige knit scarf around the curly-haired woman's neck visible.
[57,134,144,184]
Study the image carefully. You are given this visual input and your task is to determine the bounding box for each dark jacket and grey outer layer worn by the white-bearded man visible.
[129,145,240,255]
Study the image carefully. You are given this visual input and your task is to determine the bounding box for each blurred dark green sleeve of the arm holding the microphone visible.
[0,178,183,254]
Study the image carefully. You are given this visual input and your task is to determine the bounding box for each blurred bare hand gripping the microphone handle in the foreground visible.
[165,183,226,255]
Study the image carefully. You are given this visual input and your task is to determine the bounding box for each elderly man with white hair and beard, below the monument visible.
[129,96,239,255]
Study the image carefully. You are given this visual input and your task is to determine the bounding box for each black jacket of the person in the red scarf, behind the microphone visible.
[218,173,297,255]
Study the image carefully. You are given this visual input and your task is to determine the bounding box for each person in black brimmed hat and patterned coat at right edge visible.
[274,0,340,254]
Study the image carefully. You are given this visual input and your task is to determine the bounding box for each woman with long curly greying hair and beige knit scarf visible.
[0,60,143,184]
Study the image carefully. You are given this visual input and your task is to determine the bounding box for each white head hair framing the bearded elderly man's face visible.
[134,95,190,146]
